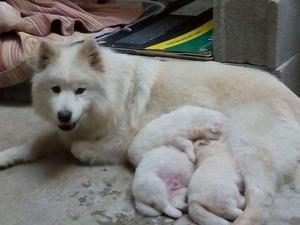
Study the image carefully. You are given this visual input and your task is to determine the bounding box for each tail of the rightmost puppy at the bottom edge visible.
[188,201,230,225]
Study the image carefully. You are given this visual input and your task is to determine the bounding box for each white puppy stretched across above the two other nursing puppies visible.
[128,106,225,166]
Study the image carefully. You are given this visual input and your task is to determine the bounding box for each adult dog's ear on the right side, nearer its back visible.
[79,39,103,71]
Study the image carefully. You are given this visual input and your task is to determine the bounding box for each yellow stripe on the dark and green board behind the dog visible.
[146,20,213,50]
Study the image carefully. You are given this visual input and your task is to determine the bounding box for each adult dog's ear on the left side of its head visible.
[36,41,58,71]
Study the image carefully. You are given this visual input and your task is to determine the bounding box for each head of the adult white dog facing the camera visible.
[32,40,113,131]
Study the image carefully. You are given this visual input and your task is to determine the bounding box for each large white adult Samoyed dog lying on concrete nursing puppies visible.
[0,40,300,225]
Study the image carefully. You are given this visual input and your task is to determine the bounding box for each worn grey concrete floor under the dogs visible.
[0,105,300,225]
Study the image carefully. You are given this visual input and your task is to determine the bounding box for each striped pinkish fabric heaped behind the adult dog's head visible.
[0,0,142,88]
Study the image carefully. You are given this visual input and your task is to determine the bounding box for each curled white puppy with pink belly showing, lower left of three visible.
[132,143,195,218]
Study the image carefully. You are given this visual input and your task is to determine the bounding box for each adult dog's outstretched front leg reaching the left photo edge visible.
[0,133,61,168]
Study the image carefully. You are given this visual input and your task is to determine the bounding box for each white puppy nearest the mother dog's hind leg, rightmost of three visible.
[188,139,245,225]
